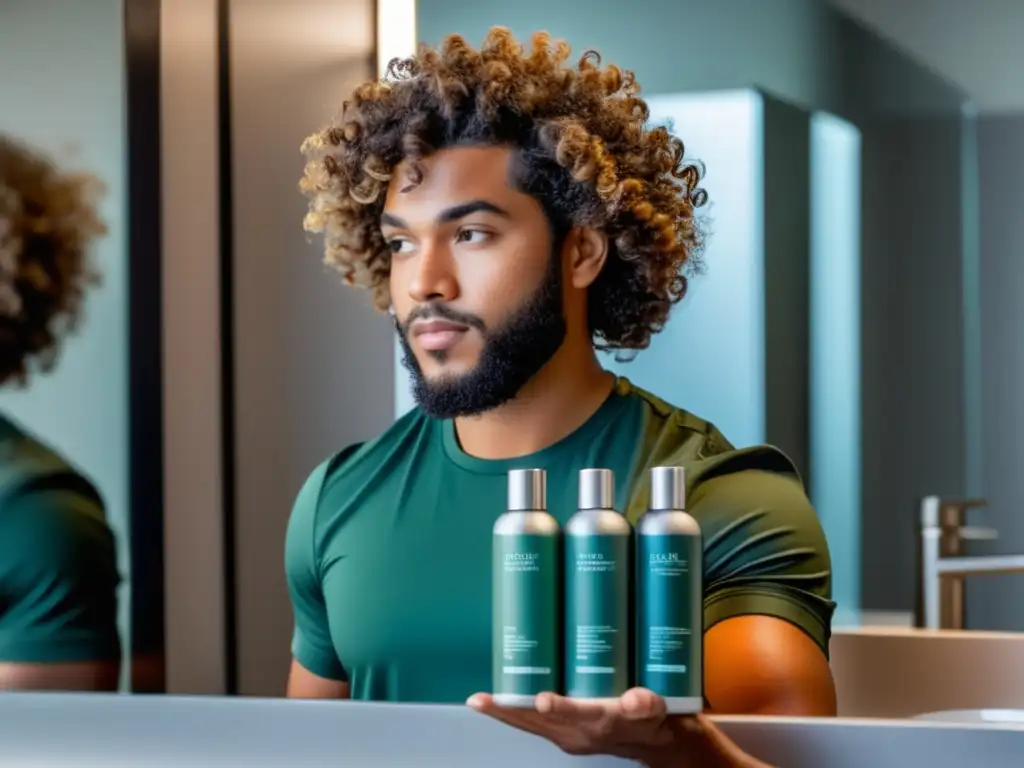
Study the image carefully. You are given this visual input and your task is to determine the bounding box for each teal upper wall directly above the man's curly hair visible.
[417,0,840,111]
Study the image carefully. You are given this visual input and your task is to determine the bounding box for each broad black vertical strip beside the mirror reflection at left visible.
[124,0,166,692]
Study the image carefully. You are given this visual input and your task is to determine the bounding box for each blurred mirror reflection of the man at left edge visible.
[0,136,121,690]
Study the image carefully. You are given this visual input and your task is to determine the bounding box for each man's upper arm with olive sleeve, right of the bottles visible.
[691,470,836,716]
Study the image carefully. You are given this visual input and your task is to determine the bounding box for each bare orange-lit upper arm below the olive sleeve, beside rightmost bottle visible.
[705,615,837,717]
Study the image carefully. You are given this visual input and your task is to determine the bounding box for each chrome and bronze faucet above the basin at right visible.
[916,496,1024,630]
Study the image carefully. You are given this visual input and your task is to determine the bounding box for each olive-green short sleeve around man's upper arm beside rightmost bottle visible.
[689,462,836,656]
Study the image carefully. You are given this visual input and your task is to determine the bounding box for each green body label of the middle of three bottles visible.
[565,536,631,698]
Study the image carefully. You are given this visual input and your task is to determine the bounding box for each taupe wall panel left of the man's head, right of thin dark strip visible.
[230,0,385,695]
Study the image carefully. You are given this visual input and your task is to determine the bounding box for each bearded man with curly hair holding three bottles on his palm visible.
[286,29,836,768]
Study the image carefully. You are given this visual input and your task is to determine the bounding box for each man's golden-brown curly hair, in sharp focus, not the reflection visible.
[299,27,707,350]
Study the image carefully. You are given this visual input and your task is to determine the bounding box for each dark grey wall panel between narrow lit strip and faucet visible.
[843,22,973,611]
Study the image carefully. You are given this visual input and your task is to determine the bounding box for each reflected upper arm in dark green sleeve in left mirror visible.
[0,489,121,691]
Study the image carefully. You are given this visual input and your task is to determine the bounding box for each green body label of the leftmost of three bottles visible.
[492,535,561,695]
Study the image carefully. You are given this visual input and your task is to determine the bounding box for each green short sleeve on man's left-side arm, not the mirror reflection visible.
[285,462,346,680]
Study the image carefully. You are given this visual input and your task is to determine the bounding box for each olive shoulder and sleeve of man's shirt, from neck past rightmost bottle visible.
[614,382,834,649]
